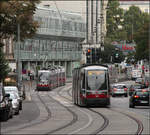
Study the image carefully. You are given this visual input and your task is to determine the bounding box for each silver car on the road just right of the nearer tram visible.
[112,84,128,97]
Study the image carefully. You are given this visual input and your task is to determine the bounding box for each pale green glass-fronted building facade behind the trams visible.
[4,7,85,77]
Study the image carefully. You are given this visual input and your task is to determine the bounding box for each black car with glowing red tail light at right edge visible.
[129,89,150,108]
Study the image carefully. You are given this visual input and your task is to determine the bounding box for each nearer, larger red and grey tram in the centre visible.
[72,64,110,106]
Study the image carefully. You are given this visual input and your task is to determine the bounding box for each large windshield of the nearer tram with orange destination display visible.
[87,70,107,90]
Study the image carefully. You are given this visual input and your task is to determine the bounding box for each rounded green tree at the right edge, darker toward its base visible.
[124,6,150,61]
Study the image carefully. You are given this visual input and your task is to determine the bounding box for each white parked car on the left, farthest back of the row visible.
[4,86,22,110]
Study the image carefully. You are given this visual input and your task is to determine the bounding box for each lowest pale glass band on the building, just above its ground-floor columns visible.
[15,50,81,61]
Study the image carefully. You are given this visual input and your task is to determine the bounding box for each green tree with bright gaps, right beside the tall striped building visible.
[106,0,126,41]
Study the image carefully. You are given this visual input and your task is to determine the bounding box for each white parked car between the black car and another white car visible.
[9,92,19,114]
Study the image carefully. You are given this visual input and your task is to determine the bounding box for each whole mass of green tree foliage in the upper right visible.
[106,0,150,62]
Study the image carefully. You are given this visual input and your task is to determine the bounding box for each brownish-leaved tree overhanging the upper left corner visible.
[0,0,39,81]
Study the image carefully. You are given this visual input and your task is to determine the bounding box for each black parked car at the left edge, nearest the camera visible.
[0,83,13,121]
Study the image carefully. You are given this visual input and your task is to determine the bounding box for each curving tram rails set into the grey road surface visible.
[2,83,144,135]
